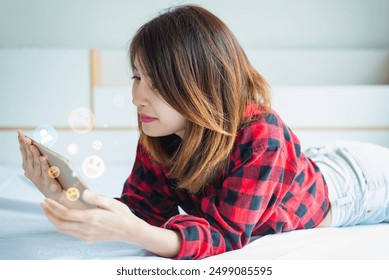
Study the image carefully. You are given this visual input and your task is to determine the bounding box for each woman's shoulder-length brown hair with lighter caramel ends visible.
[129,5,270,193]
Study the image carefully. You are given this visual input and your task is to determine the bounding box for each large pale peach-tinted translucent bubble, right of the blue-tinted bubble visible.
[68,107,95,133]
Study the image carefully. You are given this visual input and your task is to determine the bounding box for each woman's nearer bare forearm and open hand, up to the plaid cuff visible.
[42,190,181,257]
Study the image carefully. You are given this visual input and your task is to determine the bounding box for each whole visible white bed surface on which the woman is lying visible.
[0,166,389,260]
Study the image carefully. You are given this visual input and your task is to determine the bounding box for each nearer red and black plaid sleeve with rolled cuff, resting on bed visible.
[164,146,295,259]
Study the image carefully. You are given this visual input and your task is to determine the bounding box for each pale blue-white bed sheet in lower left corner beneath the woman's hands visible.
[0,198,164,260]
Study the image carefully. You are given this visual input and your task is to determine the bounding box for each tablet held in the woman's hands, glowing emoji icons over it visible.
[26,136,96,208]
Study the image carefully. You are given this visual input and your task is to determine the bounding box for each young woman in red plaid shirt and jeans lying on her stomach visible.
[19,6,389,259]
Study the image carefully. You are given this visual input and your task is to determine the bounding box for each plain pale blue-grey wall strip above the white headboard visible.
[0,0,389,49]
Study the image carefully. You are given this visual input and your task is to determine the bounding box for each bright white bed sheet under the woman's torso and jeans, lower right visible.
[211,224,389,260]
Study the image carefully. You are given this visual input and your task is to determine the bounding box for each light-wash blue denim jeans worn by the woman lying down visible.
[305,141,389,227]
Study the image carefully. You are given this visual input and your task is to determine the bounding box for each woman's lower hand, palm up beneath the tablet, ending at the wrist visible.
[41,190,148,243]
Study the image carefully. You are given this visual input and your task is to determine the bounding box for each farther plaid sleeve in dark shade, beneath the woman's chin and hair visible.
[120,143,178,226]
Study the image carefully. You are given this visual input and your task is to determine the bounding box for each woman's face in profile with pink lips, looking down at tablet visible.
[132,65,186,138]
